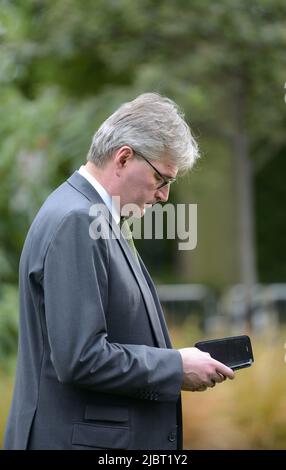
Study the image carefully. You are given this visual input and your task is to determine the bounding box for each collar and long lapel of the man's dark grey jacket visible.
[67,172,167,348]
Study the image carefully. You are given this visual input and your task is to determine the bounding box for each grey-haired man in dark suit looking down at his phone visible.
[5,93,233,450]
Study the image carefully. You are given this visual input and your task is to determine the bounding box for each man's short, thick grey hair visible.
[87,93,199,173]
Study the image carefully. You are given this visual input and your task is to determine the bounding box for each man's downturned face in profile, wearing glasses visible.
[121,157,178,216]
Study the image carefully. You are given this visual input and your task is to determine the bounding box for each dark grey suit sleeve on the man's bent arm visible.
[44,212,183,401]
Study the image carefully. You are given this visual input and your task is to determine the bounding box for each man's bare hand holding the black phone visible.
[179,348,234,392]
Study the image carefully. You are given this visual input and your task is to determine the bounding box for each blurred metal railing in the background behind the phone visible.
[157,283,286,334]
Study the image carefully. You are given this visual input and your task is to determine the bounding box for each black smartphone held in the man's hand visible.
[195,335,254,370]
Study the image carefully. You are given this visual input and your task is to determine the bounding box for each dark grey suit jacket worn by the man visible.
[5,172,183,450]
